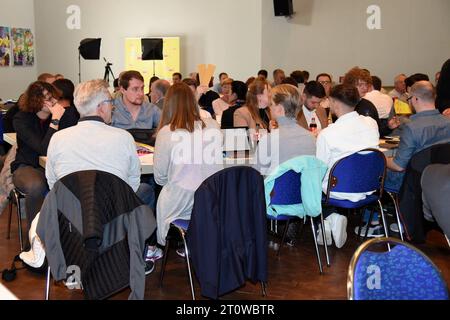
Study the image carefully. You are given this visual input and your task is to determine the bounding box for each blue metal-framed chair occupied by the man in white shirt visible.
[324,148,388,236]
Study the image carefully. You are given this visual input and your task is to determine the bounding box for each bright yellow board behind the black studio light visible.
[125,37,180,90]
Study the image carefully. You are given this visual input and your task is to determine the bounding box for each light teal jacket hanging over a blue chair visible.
[264,156,328,218]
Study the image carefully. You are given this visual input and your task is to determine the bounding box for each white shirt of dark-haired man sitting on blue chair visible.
[316,111,380,202]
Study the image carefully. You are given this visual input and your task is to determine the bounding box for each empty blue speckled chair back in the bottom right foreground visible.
[347,238,449,300]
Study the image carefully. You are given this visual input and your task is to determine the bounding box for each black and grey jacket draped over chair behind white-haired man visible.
[36,170,156,299]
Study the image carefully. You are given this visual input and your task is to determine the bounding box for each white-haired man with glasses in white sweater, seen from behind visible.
[45,80,154,274]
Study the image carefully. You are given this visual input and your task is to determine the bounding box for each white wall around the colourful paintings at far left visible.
[0,0,37,100]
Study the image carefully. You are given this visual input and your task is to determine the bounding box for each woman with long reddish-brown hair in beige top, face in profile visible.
[233,79,271,130]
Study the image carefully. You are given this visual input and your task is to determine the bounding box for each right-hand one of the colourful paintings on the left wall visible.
[11,28,34,66]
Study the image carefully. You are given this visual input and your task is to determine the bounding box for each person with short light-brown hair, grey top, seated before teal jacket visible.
[255,84,316,175]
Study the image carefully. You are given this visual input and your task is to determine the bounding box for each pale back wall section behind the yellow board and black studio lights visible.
[35,0,261,86]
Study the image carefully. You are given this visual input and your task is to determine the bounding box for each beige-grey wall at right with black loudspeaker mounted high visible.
[262,0,450,85]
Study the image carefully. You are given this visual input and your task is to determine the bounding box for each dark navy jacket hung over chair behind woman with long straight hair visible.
[187,167,267,299]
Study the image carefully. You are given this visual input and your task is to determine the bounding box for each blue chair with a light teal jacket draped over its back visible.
[267,170,330,274]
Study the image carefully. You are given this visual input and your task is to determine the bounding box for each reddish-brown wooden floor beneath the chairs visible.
[0,205,450,300]
